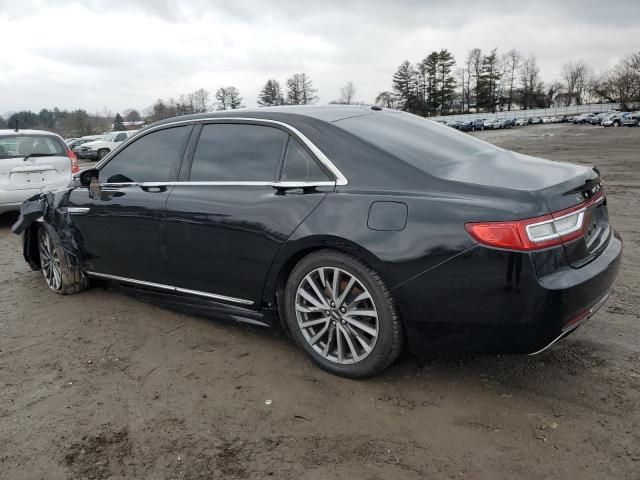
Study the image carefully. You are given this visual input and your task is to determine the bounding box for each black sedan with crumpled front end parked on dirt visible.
[14,106,622,377]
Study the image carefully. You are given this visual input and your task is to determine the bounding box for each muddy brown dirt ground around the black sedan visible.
[0,124,640,480]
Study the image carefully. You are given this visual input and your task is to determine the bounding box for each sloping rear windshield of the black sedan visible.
[334,112,502,175]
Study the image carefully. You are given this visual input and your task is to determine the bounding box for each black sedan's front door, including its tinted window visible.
[69,125,193,283]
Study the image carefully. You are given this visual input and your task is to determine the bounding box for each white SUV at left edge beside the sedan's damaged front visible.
[0,130,80,213]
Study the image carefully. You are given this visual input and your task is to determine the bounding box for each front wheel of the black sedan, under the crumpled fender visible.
[38,224,89,295]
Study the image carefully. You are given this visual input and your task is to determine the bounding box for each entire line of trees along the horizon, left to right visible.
[0,48,640,137]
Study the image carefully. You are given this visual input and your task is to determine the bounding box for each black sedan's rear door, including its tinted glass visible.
[167,122,335,306]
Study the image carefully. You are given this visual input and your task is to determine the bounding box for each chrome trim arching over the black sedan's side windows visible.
[95,117,349,185]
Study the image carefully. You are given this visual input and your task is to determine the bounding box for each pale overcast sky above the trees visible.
[0,0,640,114]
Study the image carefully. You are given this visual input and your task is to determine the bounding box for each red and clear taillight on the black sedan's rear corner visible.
[465,193,604,251]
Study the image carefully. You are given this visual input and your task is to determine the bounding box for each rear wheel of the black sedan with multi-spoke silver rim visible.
[284,250,403,378]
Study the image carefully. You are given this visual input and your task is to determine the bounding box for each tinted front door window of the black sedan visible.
[100,126,191,183]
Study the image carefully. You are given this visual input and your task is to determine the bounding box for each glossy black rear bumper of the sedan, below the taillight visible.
[393,234,622,353]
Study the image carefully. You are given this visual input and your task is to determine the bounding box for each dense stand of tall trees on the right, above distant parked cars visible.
[375,48,640,117]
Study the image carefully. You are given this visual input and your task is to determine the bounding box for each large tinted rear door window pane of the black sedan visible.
[189,124,288,182]
